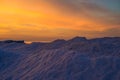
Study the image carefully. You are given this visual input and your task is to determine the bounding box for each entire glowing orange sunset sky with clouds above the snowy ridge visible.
[0,0,120,41]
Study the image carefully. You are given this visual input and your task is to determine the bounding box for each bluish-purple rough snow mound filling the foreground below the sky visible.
[0,37,120,80]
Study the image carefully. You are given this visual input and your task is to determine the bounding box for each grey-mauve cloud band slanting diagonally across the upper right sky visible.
[45,0,120,26]
